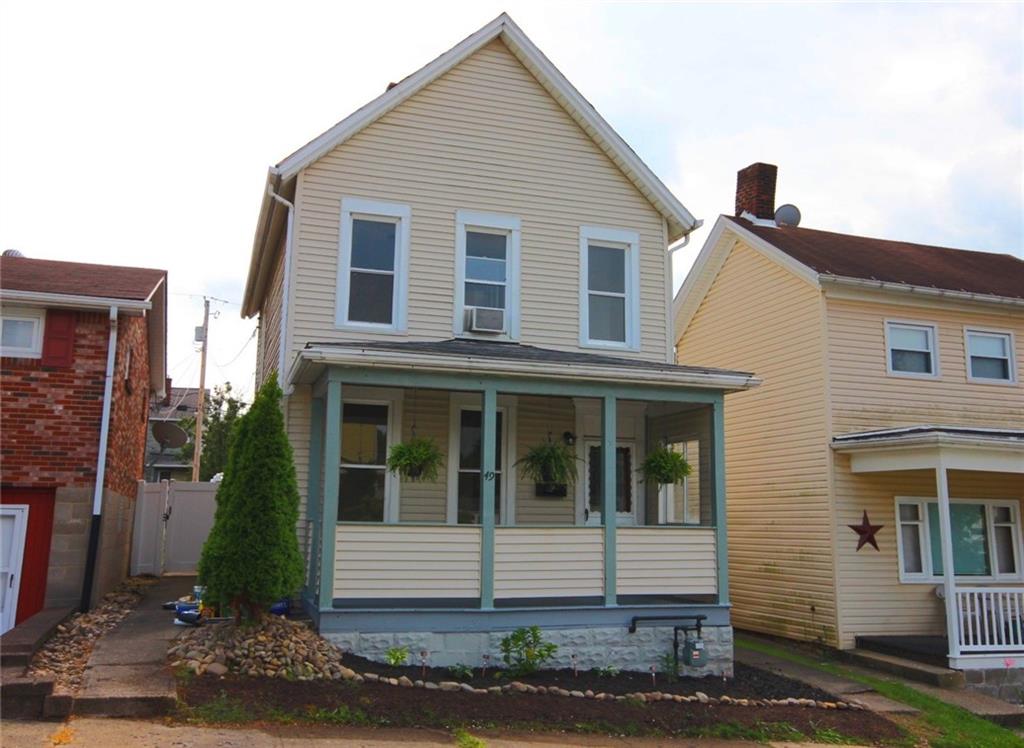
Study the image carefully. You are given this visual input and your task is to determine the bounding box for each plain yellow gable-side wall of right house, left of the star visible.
[677,242,836,643]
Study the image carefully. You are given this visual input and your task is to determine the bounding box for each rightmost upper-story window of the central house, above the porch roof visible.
[580,226,640,348]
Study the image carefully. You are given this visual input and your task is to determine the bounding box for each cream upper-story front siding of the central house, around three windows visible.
[291,40,668,361]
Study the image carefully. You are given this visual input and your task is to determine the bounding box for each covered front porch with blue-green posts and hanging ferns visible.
[284,341,756,668]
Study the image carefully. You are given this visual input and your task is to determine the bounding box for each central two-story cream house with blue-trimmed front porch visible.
[244,14,758,673]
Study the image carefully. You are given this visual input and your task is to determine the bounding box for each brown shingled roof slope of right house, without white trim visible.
[726,216,1024,298]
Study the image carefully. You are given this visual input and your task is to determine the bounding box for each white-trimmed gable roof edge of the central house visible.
[242,13,703,317]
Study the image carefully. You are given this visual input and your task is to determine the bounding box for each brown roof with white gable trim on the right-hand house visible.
[673,215,1024,339]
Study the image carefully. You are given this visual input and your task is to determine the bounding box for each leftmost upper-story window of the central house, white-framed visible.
[335,198,412,331]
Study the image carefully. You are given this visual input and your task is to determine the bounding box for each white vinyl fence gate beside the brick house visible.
[131,481,217,576]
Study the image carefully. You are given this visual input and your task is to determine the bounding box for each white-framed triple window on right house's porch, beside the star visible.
[897,499,1021,582]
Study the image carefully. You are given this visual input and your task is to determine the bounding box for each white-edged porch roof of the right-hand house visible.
[831,425,1024,473]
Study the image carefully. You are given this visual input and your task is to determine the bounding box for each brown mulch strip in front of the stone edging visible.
[179,675,902,743]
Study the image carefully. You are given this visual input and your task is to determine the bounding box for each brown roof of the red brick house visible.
[0,257,167,301]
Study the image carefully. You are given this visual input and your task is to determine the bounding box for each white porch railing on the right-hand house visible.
[956,587,1024,654]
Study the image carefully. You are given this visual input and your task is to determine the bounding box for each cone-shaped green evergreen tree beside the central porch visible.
[200,375,303,623]
